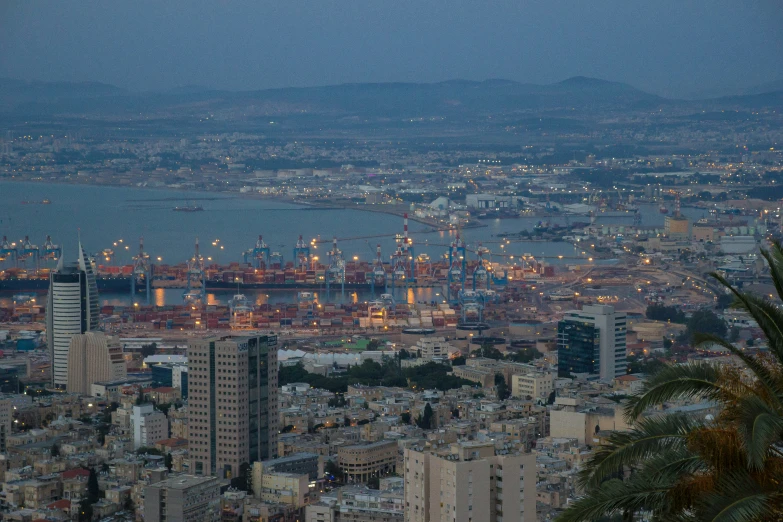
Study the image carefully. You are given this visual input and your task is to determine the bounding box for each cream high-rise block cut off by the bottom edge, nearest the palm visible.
[403,442,536,522]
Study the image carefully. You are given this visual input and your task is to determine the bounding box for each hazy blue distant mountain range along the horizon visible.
[0,76,783,119]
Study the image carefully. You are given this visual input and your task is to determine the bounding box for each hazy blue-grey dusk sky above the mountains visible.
[0,0,783,94]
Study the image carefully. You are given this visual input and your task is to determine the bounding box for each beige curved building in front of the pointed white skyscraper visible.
[66,332,127,395]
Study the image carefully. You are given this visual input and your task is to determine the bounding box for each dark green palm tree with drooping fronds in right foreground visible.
[557,242,783,522]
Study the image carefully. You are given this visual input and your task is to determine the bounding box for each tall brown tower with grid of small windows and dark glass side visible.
[188,335,278,478]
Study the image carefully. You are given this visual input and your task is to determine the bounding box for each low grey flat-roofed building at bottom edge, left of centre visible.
[144,475,220,522]
